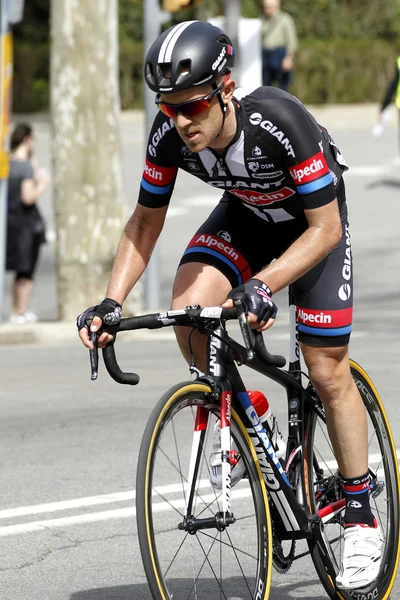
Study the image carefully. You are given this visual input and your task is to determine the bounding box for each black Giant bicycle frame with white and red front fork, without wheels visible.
[196,307,315,539]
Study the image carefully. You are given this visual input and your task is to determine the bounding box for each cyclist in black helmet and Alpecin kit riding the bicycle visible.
[77,21,383,588]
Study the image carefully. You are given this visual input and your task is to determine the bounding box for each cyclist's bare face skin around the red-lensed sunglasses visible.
[160,84,223,152]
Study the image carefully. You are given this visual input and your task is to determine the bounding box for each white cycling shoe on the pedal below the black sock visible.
[336,525,384,590]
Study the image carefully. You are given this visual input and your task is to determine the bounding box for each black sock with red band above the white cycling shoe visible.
[342,473,375,527]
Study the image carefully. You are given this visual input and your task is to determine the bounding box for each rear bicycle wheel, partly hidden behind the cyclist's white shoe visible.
[305,361,400,600]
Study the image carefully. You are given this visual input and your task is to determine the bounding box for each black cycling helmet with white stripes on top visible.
[144,21,235,94]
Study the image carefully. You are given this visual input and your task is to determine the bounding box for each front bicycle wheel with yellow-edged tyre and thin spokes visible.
[136,382,272,600]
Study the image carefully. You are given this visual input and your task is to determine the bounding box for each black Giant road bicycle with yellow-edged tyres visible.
[91,300,400,600]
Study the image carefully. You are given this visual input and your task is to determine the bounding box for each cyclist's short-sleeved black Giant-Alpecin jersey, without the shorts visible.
[139,87,347,223]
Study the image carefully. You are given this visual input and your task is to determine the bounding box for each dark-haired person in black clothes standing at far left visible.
[6,123,50,325]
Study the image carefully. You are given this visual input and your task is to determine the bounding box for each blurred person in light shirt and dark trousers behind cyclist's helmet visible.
[261,0,297,90]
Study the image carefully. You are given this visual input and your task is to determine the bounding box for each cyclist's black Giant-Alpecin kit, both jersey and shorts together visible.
[139,87,353,347]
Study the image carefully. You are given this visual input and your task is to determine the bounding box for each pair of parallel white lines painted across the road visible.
[0,449,400,537]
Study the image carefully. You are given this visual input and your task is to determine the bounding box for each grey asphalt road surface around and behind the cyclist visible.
[0,105,400,600]
